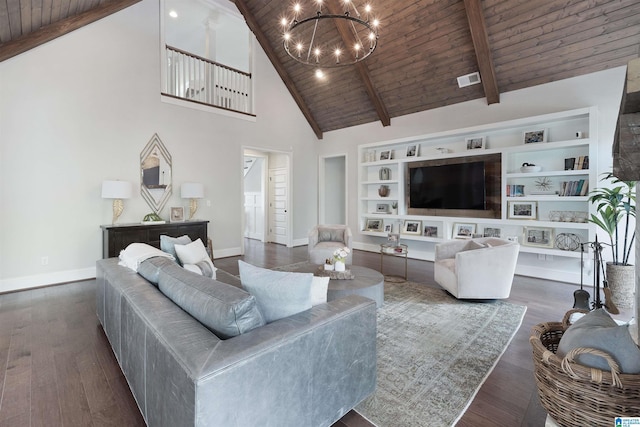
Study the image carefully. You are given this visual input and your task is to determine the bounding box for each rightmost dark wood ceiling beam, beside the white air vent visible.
[464,0,500,104]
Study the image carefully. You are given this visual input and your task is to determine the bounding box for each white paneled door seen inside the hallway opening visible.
[269,168,289,245]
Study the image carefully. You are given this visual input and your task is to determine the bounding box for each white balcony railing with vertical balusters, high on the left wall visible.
[165,46,253,114]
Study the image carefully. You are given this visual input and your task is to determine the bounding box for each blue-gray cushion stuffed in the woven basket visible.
[557,308,640,374]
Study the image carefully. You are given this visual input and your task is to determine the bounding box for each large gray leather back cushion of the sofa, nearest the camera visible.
[158,264,265,339]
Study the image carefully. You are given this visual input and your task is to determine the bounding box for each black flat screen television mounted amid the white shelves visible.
[409,161,486,210]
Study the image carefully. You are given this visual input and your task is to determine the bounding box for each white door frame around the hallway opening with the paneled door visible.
[239,145,293,255]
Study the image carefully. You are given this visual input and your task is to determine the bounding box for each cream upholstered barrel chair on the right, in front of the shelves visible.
[434,237,520,299]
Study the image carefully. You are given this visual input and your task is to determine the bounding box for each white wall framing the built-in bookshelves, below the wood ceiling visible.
[319,67,625,278]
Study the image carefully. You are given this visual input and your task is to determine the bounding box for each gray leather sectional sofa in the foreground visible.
[96,258,376,427]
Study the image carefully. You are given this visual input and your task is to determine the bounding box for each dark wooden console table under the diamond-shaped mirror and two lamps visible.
[100,221,209,258]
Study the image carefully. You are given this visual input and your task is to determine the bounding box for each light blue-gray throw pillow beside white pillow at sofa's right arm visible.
[238,261,313,323]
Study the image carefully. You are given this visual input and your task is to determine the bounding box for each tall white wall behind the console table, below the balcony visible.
[0,0,317,292]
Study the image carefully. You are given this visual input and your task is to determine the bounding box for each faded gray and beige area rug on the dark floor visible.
[355,282,526,427]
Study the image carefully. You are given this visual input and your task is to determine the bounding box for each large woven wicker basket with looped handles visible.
[529,311,640,427]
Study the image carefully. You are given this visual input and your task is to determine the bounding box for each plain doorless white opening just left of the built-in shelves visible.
[318,154,348,224]
